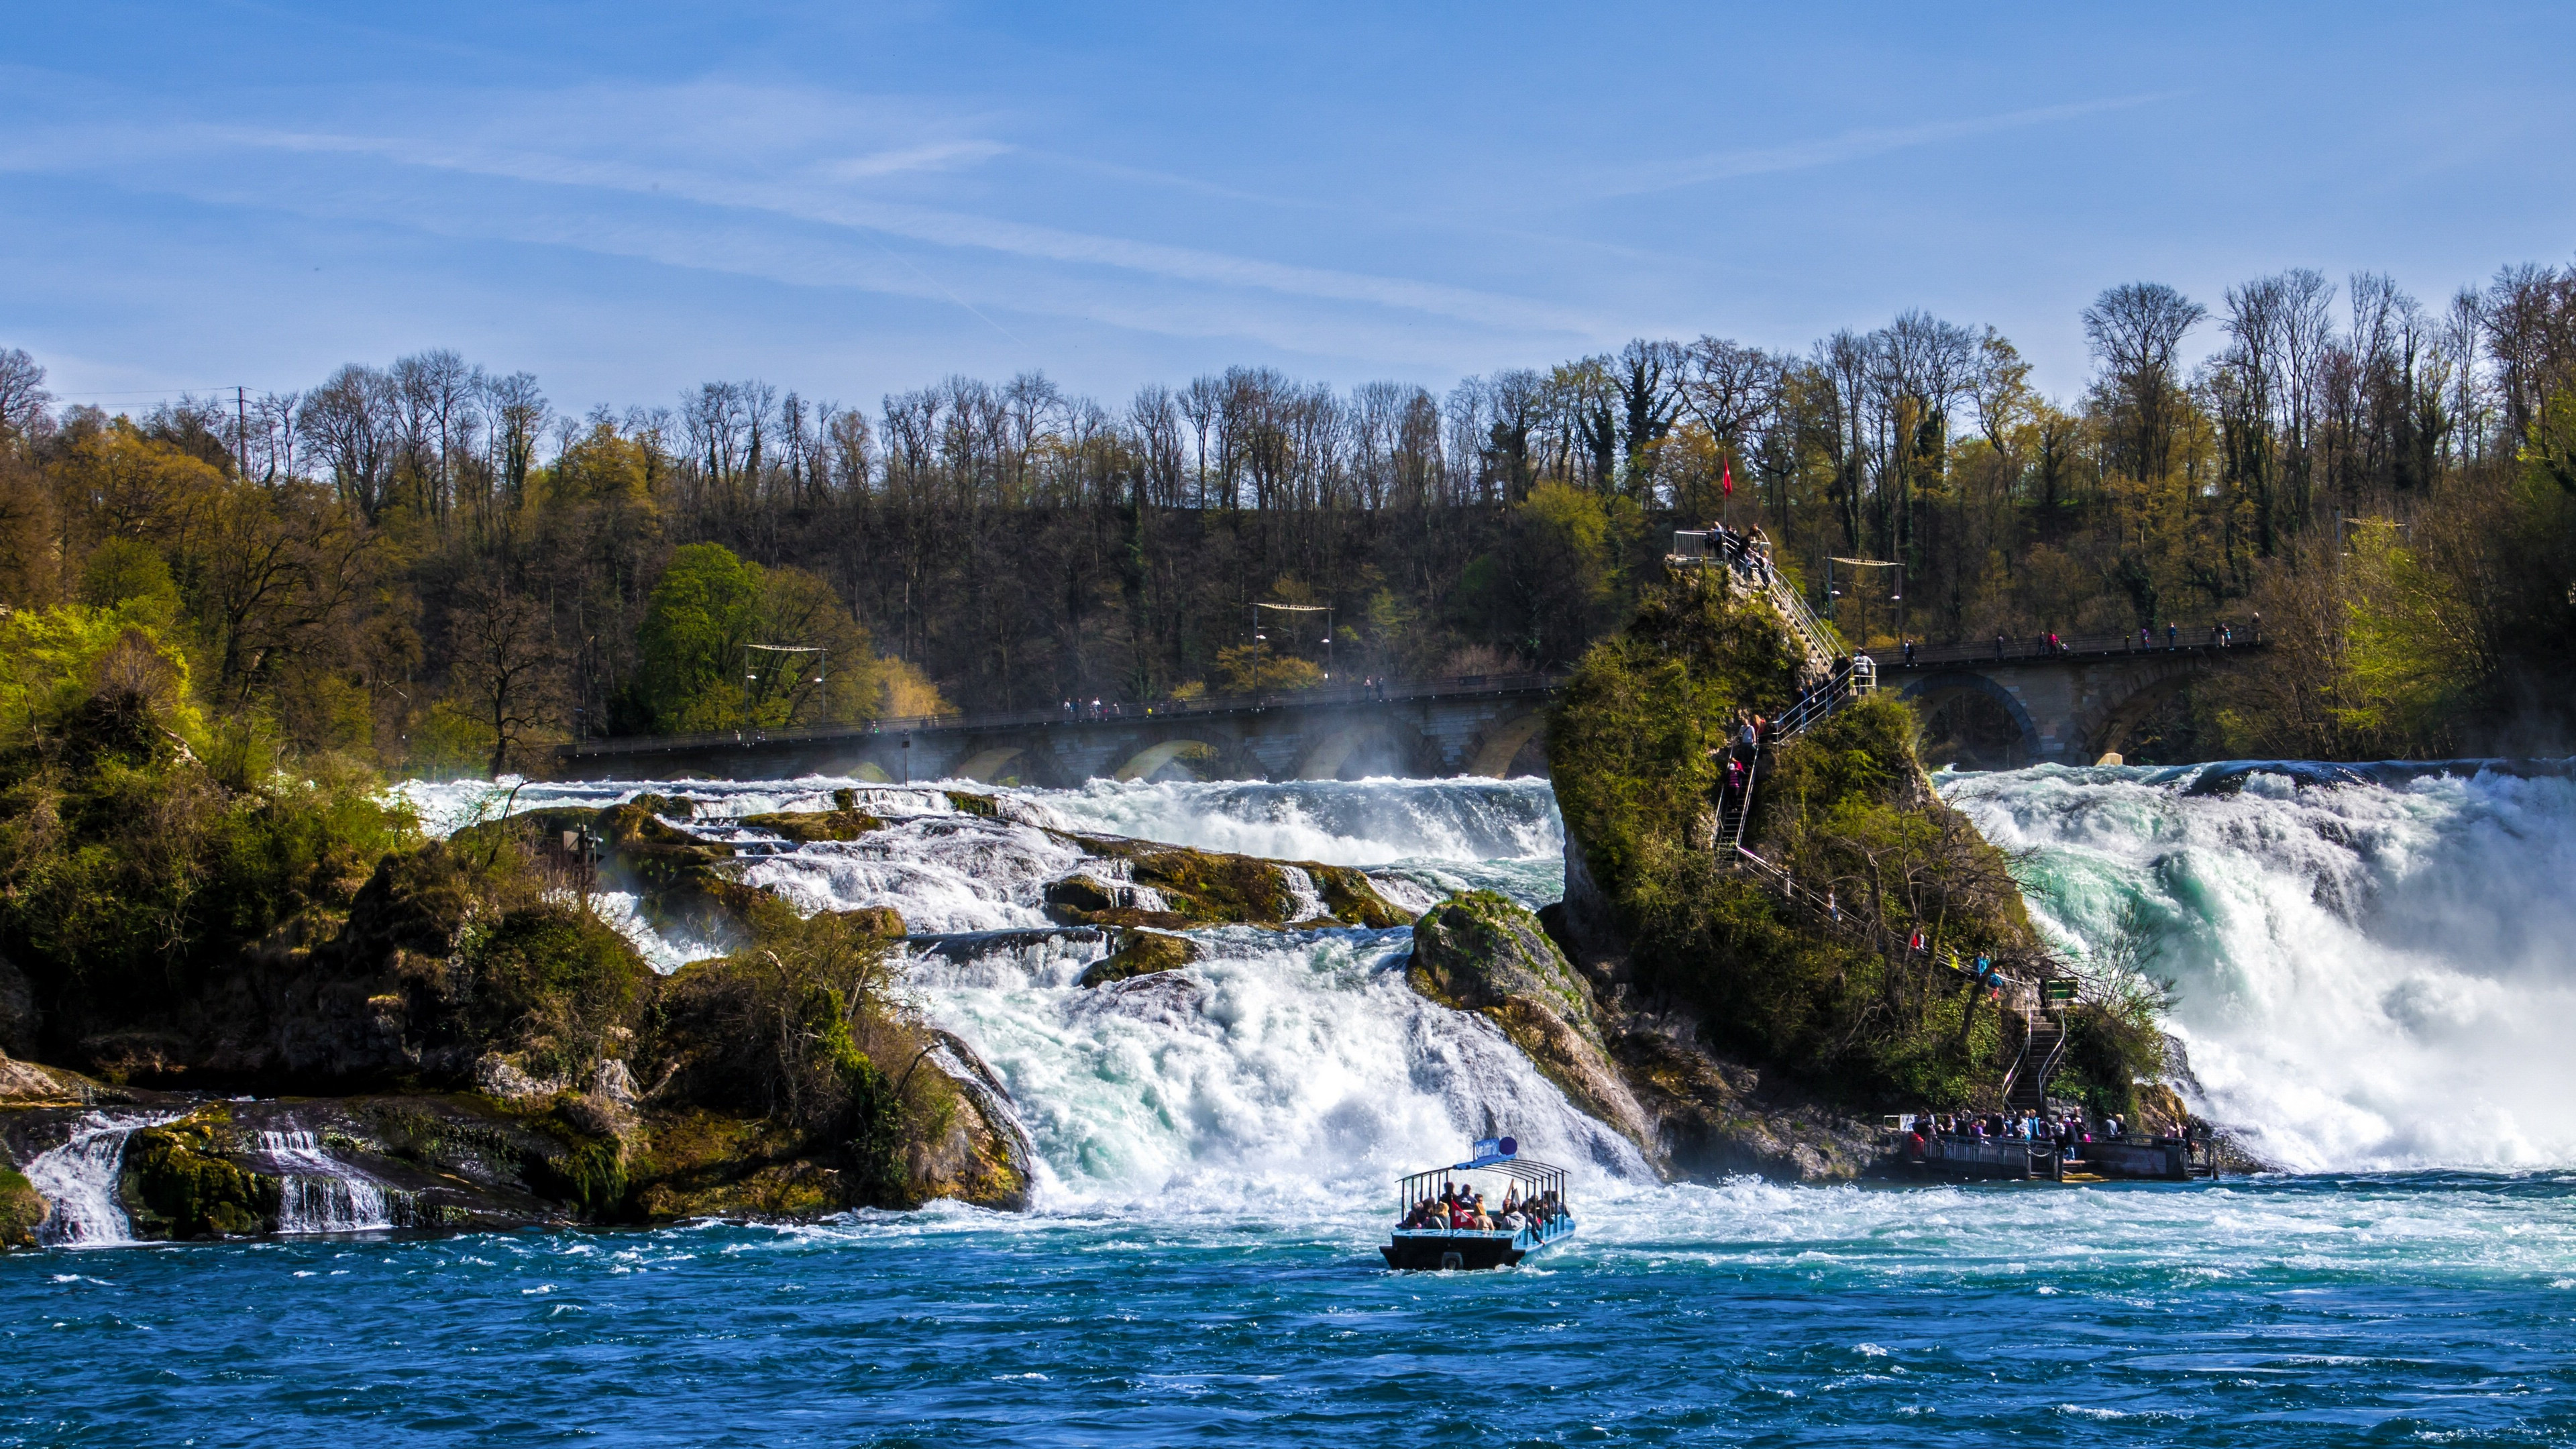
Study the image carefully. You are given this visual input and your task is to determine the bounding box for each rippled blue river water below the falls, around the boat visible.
[15,1176,2576,1444]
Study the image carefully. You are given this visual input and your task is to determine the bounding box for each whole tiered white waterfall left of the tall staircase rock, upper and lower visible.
[386,779,1654,1212]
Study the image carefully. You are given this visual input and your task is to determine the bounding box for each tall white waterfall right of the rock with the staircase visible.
[1942,765,2576,1171]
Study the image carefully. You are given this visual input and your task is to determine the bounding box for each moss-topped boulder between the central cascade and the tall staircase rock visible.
[1404,890,1656,1158]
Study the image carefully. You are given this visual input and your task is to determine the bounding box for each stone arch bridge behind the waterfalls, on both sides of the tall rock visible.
[556,637,2257,786]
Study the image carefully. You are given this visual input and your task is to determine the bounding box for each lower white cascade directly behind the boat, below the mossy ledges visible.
[910,928,1651,1212]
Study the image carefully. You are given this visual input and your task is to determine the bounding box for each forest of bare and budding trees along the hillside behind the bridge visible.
[0,263,2576,773]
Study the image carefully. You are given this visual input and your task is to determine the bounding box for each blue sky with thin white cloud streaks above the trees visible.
[0,0,2576,410]
